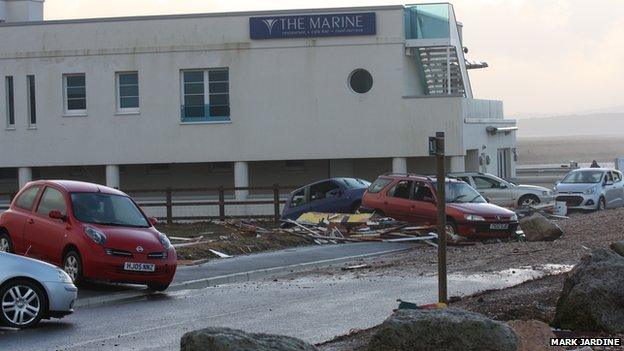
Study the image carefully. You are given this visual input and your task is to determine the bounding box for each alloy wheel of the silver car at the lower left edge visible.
[0,279,48,328]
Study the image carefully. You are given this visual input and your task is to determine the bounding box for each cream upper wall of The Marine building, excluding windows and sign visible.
[0,7,464,167]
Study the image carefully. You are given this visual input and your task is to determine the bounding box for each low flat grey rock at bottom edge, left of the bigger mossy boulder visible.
[180,328,318,351]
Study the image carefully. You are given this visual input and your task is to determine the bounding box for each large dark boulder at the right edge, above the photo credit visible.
[553,249,624,334]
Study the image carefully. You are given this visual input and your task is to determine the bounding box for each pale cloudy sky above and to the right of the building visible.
[44,0,624,118]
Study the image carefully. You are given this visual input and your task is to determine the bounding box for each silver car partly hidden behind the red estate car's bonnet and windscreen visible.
[449,172,554,208]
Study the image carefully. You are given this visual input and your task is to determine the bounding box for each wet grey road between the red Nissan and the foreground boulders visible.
[0,271,552,351]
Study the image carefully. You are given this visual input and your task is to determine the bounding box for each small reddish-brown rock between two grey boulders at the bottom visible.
[507,320,564,351]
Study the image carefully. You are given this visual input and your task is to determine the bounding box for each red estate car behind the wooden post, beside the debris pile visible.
[362,174,518,239]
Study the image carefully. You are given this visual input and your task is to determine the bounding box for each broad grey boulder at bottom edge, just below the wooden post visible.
[368,308,517,351]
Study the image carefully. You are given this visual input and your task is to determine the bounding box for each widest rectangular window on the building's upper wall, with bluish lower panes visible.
[181,68,230,122]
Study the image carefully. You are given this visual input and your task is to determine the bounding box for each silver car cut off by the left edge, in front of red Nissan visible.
[0,252,78,328]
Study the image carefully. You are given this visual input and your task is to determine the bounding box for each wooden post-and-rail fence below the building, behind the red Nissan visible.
[0,184,298,223]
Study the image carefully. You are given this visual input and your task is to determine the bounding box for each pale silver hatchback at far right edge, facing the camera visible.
[555,168,624,210]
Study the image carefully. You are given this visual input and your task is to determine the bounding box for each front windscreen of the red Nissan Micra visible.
[71,193,150,228]
